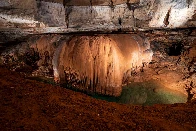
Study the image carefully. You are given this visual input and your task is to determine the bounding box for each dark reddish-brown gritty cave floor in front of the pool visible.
[0,67,196,131]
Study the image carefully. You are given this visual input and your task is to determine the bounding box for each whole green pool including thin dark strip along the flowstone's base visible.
[28,77,187,105]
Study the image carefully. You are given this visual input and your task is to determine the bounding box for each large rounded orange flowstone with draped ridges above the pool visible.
[53,35,152,96]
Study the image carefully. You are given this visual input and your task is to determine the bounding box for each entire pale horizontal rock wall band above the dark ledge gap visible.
[0,0,196,32]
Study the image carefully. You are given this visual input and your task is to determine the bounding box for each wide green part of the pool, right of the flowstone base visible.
[118,81,187,105]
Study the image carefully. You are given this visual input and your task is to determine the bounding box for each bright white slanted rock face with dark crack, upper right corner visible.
[149,0,196,28]
